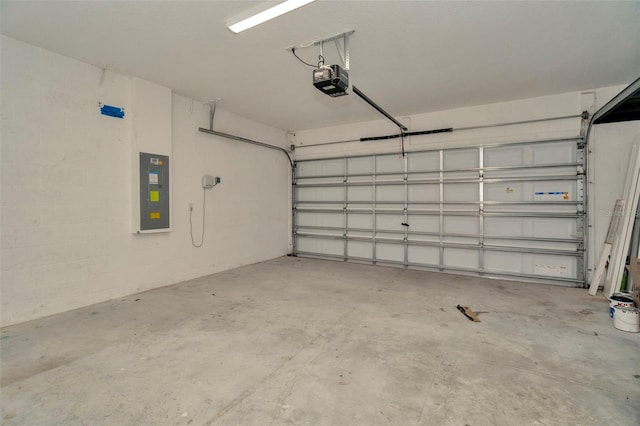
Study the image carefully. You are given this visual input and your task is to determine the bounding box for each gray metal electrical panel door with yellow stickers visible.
[140,152,170,231]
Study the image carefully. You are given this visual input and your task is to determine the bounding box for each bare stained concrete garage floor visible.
[1,258,640,426]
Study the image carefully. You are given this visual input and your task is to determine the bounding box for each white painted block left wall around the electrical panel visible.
[0,36,290,325]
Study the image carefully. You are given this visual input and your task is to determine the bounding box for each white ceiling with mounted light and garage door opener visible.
[0,0,640,130]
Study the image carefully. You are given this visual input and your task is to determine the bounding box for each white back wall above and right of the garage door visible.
[294,86,640,282]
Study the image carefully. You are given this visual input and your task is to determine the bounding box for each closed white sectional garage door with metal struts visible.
[293,138,587,286]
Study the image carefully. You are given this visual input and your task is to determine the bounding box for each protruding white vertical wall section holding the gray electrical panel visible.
[131,78,172,234]
